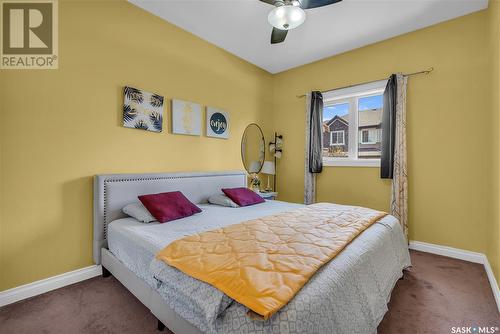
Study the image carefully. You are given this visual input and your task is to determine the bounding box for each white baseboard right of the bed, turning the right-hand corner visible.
[410,240,500,312]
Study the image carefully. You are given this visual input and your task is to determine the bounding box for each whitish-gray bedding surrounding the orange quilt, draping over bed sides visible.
[108,201,411,334]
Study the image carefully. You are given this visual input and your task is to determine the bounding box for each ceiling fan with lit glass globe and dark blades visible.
[260,0,342,44]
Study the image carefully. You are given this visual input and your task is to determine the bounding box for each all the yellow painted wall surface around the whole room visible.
[0,1,500,290]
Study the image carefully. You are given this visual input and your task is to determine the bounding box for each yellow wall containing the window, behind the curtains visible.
[273,11,491,253]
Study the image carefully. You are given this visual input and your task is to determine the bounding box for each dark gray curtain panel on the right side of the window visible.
[380,74,397,179]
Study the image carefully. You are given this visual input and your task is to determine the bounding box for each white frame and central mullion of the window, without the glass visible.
[322,80,387,167]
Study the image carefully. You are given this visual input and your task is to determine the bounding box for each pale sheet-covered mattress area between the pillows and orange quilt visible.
[108,201,303,288]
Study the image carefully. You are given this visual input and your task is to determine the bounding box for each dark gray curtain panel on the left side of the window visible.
[309,92,323,173]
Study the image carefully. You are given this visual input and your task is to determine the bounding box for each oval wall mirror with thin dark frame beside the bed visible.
[241,123,266,174]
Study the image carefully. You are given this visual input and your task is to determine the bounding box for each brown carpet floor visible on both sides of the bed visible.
[0,251,500,334]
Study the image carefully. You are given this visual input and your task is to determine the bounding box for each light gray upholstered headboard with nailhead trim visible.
[93,171,247,264]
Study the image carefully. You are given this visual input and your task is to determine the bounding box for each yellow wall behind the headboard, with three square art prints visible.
[0,1,273,290]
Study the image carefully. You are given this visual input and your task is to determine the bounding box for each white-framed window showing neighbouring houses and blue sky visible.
[323,80,387,167]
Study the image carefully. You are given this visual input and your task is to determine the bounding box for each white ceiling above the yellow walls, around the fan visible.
[129,0,488,73]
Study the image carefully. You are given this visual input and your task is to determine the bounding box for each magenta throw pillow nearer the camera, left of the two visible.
[138,191,201,223]
